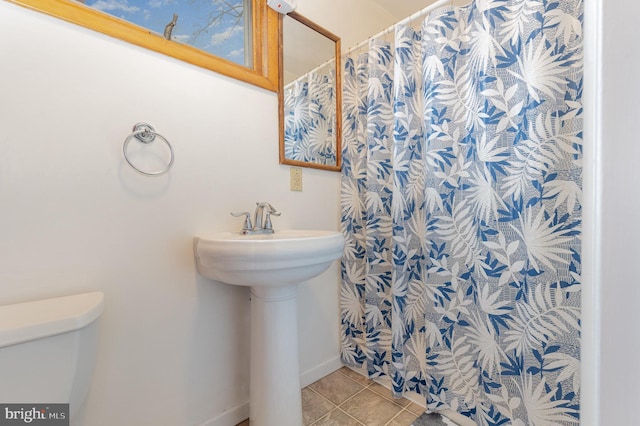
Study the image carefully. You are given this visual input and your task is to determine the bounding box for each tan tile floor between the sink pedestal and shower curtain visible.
[237,367,425,426]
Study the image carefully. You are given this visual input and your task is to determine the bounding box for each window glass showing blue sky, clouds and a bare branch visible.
[76,0,253,68]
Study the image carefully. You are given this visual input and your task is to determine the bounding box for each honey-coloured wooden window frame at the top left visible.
[8,0,281,92]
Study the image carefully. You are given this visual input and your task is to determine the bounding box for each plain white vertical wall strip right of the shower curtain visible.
[587,0,640,425]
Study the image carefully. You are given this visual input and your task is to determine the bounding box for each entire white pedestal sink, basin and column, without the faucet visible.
[194,230,344,426]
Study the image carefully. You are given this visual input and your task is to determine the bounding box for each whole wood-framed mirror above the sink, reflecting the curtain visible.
[280,12,341,171]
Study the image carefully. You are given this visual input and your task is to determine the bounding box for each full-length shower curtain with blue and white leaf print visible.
[340,0,583,426]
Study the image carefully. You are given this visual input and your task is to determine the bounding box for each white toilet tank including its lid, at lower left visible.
[0,292,104,421]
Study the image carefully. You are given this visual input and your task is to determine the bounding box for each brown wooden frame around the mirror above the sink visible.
[278,12,342,172]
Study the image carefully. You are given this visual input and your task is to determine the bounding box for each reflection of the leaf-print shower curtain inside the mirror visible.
[283,60,337,165]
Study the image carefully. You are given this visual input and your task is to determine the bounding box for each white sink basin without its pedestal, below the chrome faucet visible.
[194,230,344,287]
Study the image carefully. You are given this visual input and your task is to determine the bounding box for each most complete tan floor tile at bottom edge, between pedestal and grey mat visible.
[340,389,402,426]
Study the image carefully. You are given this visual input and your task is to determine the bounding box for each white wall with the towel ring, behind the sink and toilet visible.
[0,0,400,426]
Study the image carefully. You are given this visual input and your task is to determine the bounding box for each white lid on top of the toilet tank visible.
[0,292,104,348]
